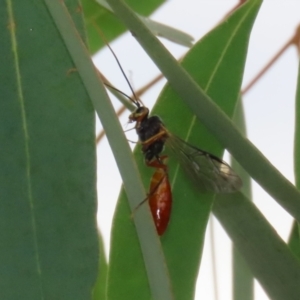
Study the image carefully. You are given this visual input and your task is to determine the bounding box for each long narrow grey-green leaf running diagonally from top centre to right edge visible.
[109,0,300,221]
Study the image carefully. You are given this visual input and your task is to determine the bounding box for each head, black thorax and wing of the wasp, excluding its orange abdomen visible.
[129,100,242,193]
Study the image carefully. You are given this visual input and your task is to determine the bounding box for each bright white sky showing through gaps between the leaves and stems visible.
[95,0,300,300]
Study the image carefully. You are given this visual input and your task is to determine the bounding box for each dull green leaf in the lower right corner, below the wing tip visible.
[213,193,300,300]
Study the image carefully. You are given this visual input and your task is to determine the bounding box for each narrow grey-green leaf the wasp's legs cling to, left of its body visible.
[45,0,171,300]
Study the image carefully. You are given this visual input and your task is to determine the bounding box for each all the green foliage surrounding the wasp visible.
[0,0,300,300]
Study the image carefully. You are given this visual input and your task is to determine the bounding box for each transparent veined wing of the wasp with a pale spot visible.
[166,134,242,193]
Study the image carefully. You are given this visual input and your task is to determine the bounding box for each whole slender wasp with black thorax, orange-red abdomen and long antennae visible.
[102,43,242,235]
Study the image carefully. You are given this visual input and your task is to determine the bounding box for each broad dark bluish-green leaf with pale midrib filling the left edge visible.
[0,0,98,300]
